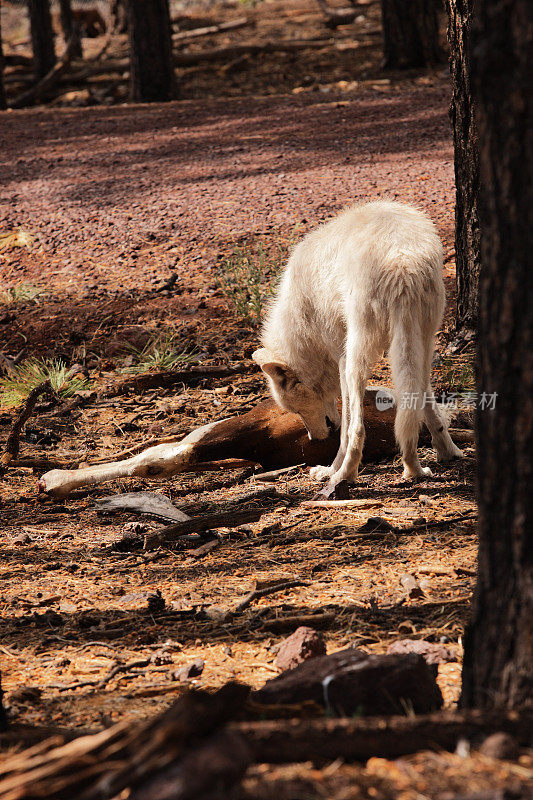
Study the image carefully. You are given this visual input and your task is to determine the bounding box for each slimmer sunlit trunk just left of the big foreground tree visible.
[446,0,480,330]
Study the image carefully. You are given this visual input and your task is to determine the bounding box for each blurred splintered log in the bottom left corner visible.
[0,683,248,800]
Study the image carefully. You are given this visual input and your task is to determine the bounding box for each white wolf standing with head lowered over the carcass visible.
[253,202,462,486]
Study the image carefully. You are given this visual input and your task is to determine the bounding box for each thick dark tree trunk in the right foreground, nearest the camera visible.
[462,0,533,708]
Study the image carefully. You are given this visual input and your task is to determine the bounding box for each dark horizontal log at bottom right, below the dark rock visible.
[228,709,533,764]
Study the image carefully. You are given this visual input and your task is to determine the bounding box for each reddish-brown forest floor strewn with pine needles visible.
[0,0,532,800]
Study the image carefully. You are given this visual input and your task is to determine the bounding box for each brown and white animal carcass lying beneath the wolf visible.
[38,387,396,497]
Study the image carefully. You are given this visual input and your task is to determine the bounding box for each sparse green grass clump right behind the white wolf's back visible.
[217,228,298,327]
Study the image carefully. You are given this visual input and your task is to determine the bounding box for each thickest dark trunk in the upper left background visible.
[128,0,174,102]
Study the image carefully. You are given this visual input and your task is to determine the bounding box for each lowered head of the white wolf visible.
[252,347,340,439]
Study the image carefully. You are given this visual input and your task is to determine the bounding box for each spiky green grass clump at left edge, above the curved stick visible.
[0,358,90,408]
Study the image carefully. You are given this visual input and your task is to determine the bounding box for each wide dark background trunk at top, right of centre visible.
[381,0,442,69]
